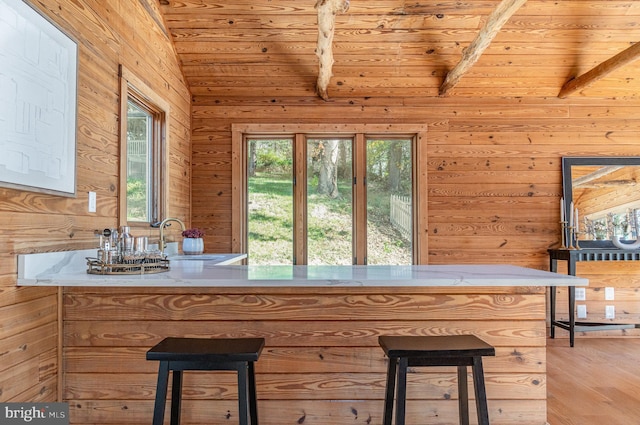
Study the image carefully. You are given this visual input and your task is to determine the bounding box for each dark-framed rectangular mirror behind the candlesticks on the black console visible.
[562,157,640,248]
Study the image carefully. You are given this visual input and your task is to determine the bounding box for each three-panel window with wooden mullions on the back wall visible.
[246,134,414,265]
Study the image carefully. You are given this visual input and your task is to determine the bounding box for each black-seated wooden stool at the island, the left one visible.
[147,337,264,425]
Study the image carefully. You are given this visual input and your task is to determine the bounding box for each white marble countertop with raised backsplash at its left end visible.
[18,247,589,287]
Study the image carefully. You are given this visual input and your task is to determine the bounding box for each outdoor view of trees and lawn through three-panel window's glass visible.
[247,138,412,265]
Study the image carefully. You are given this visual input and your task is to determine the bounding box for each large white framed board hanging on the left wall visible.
[0,0,78,196]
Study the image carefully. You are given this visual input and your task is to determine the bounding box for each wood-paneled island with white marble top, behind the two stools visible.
[17,261,588,425]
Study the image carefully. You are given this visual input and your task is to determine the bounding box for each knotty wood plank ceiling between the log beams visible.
[159,0,640,100]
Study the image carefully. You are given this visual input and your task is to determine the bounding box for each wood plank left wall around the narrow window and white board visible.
[0,0,191,402]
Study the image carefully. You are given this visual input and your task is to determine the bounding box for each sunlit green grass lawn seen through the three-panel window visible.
[249,173,411,265]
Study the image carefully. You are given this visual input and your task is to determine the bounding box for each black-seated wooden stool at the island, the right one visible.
[378,335,496,425]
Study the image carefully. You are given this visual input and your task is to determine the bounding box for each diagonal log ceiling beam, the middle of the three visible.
[439,0,527,96]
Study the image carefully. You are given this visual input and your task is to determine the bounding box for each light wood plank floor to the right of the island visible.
[547,338,640,425]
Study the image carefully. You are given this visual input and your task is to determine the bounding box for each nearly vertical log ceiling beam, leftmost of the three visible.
[315,0,349,100]
